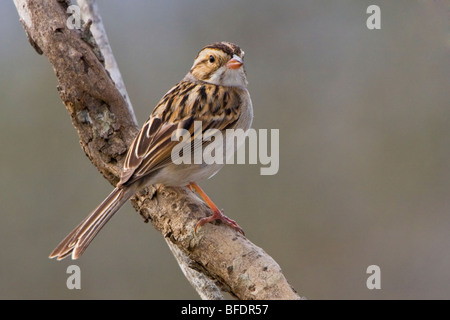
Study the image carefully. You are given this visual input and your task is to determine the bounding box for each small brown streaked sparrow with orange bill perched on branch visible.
[49,42,253,260]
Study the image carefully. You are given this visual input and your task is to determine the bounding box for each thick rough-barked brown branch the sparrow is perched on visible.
[14,0,300,300]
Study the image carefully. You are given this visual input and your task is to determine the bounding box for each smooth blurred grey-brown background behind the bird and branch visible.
[0,0,450,299]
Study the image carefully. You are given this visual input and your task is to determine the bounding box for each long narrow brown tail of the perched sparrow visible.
[49,188,132,260]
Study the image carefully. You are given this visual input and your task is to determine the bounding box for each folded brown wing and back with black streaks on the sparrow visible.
[119,81,241,184]
